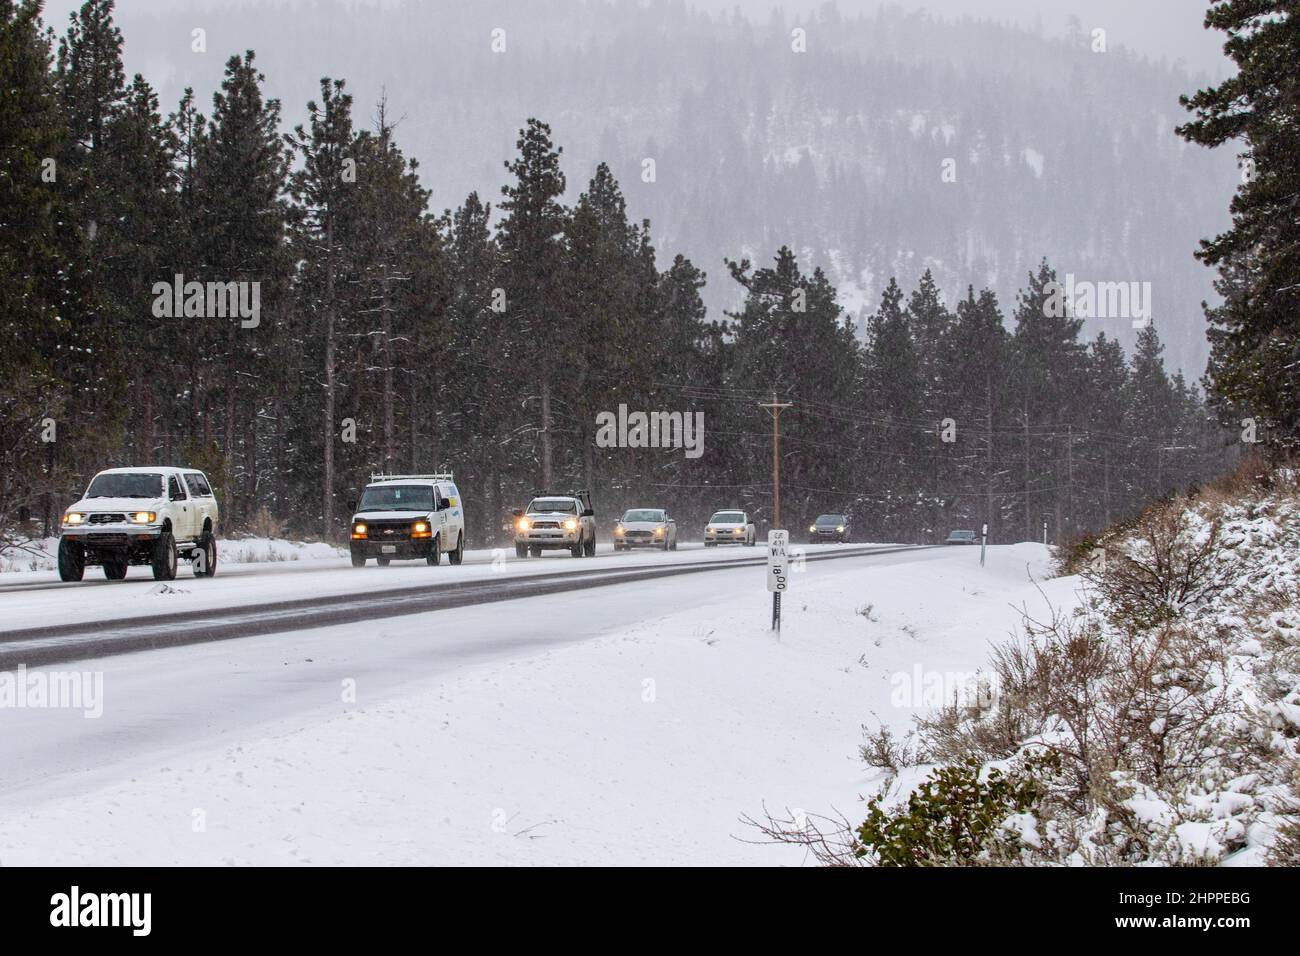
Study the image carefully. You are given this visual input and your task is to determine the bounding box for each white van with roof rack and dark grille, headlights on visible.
[350,472,465,567]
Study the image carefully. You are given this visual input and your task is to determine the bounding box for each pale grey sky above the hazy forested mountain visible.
[46,0,1229,78]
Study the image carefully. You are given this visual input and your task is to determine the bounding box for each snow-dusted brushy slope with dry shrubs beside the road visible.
[761,471,1300,865]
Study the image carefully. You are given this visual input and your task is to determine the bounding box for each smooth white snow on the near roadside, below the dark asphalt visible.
[0,545,1050,865]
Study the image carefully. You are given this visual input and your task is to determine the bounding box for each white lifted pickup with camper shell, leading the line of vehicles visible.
[59,466,218,581]
